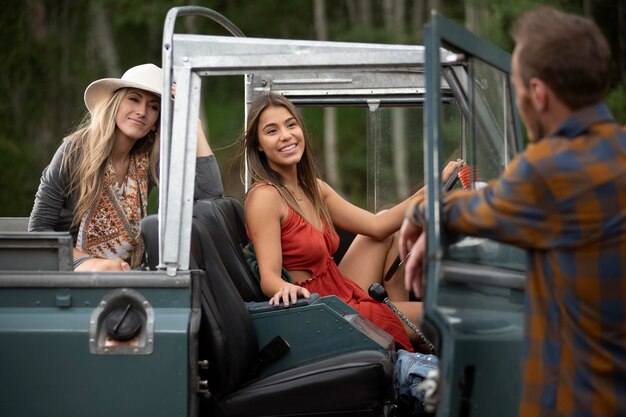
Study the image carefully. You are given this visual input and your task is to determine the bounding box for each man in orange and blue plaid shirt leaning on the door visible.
[400,7,626,417]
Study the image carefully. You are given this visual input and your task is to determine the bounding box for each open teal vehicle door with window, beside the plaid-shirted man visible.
[424,14,526,416]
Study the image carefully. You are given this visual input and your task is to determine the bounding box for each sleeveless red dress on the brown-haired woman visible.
[280,206,413,351]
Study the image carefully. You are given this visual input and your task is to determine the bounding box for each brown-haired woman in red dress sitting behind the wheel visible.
[244,93,454,351]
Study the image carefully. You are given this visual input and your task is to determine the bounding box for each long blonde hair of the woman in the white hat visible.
[62,88,159,225]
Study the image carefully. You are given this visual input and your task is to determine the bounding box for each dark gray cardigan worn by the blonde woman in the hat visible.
[28,142,224,244]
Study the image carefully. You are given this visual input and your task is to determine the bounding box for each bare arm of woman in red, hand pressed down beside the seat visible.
[245,186,309,306]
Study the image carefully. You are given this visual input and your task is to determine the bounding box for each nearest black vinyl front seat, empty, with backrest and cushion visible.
[192,202,393,417]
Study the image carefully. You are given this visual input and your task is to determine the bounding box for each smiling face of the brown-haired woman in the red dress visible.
[257,106,306,173]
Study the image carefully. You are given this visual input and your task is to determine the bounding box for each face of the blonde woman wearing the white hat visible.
[115,88,161,140]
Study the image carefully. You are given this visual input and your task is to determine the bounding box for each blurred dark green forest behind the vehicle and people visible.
[0,0,626,216]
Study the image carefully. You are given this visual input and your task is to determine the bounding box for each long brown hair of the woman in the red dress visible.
[243,92,333,228]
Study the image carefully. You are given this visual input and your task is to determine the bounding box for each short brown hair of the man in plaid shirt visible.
[511,7,611,110]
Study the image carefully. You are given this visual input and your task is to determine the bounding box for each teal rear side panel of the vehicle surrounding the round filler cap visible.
[0,273,192,417]
